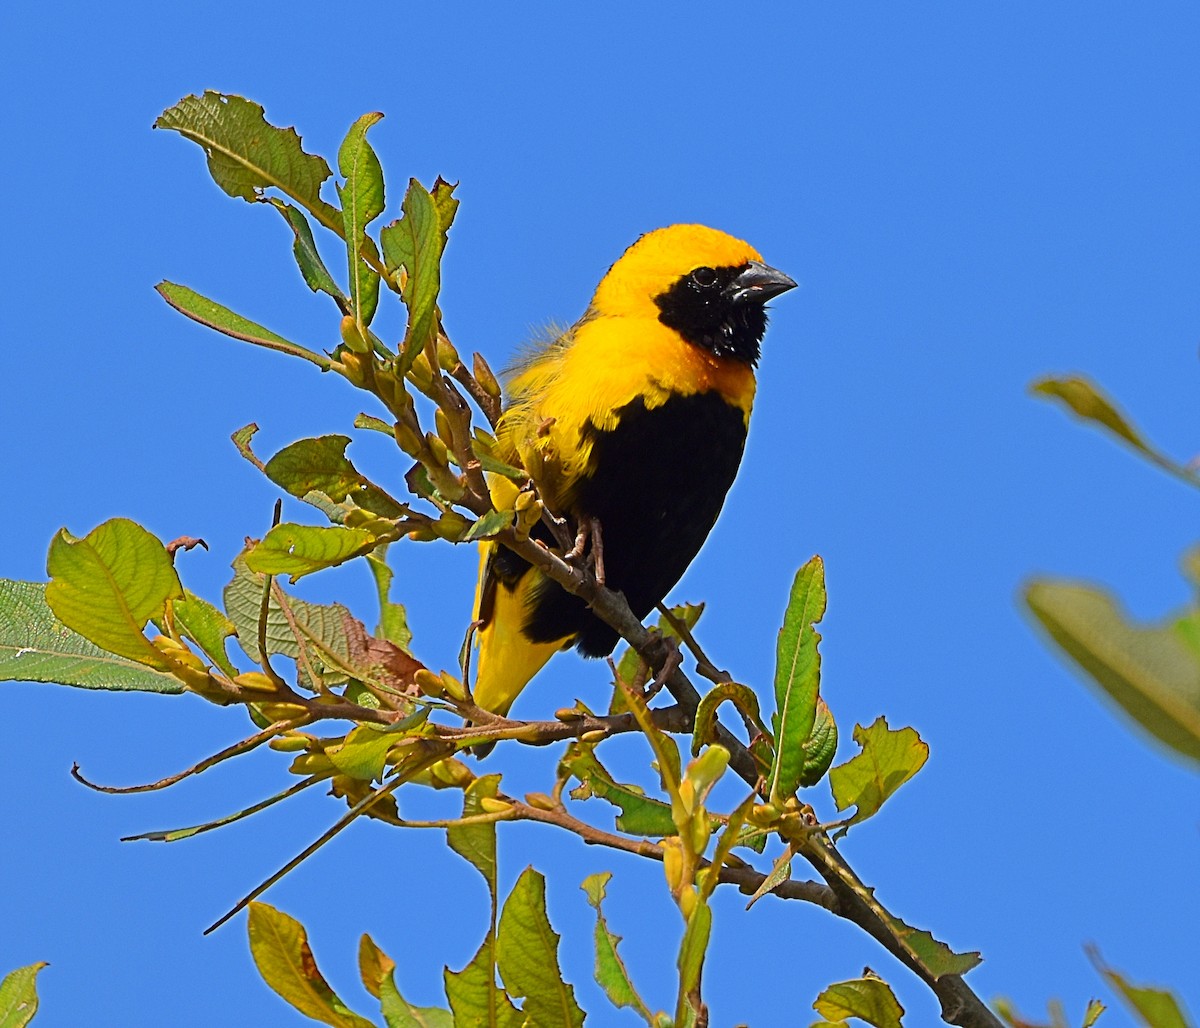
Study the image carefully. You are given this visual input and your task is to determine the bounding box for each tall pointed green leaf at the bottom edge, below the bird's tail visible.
[497,867,583,1028]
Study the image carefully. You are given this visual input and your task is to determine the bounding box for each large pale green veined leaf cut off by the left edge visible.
[0,578,184,693]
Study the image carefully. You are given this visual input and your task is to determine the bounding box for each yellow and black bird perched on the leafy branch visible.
[474,224,796,714]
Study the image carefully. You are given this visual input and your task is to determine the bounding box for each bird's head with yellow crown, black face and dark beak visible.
[592,224,796,365]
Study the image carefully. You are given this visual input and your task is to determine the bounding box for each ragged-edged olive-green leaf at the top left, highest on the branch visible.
[155,90,341,229]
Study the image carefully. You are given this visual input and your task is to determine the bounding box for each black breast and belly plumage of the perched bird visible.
[524,392,746,657]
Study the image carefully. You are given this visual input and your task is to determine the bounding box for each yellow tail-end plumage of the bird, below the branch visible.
[473,542,571,715]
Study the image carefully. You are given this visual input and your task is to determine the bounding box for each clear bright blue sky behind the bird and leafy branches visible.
[0,0,1200,1028]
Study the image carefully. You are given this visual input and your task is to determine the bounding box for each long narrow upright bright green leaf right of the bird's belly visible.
[768,557,826,804]
